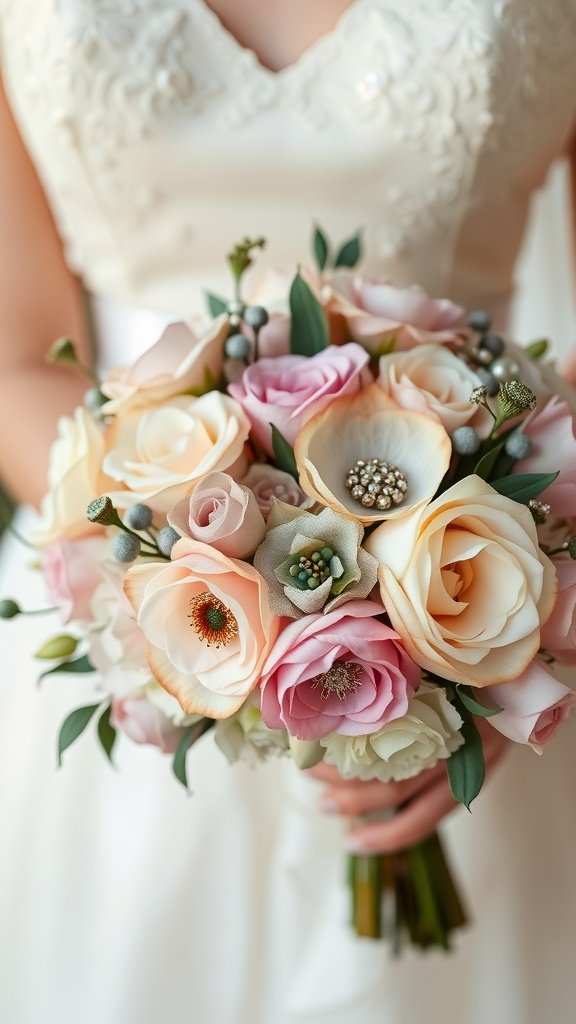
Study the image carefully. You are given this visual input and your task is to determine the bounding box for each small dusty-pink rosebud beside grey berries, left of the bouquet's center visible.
[168,473,265,558]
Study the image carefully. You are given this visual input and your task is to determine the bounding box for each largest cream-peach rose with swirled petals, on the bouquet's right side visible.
[365,476,556,686]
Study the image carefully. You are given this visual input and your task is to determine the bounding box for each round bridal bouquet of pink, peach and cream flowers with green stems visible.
[0,230,576,948]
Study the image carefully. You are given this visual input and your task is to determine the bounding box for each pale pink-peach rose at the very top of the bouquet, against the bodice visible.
[328,276,465,351]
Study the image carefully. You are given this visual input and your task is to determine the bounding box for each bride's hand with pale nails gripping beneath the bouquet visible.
[311,721,509,853]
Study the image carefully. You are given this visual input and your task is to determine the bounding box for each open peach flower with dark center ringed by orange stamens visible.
[125,538,279,719]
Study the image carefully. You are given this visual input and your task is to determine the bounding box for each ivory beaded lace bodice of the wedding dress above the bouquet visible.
[0,0,576,313]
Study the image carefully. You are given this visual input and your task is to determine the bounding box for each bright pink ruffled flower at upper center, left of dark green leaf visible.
[228,342,368,455]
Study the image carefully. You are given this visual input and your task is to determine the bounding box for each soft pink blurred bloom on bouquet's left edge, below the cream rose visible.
[41,534,107,623]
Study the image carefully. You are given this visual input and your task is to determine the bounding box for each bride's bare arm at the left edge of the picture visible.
[0,74,86,503]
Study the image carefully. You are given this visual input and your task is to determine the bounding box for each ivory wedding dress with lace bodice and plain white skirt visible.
[0,0,576,1024]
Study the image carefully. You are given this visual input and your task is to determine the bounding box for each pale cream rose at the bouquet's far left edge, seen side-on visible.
[34,406,112,545]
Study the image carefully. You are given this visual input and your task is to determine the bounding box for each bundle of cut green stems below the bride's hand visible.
[348,833,467,955]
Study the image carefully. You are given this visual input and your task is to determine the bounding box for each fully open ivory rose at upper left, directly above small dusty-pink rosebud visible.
[104,391,250,512]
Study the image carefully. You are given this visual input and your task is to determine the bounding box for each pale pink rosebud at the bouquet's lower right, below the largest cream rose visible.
[481,657,576,754]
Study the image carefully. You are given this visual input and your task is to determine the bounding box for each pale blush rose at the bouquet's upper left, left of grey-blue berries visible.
[101,316,230,416]
